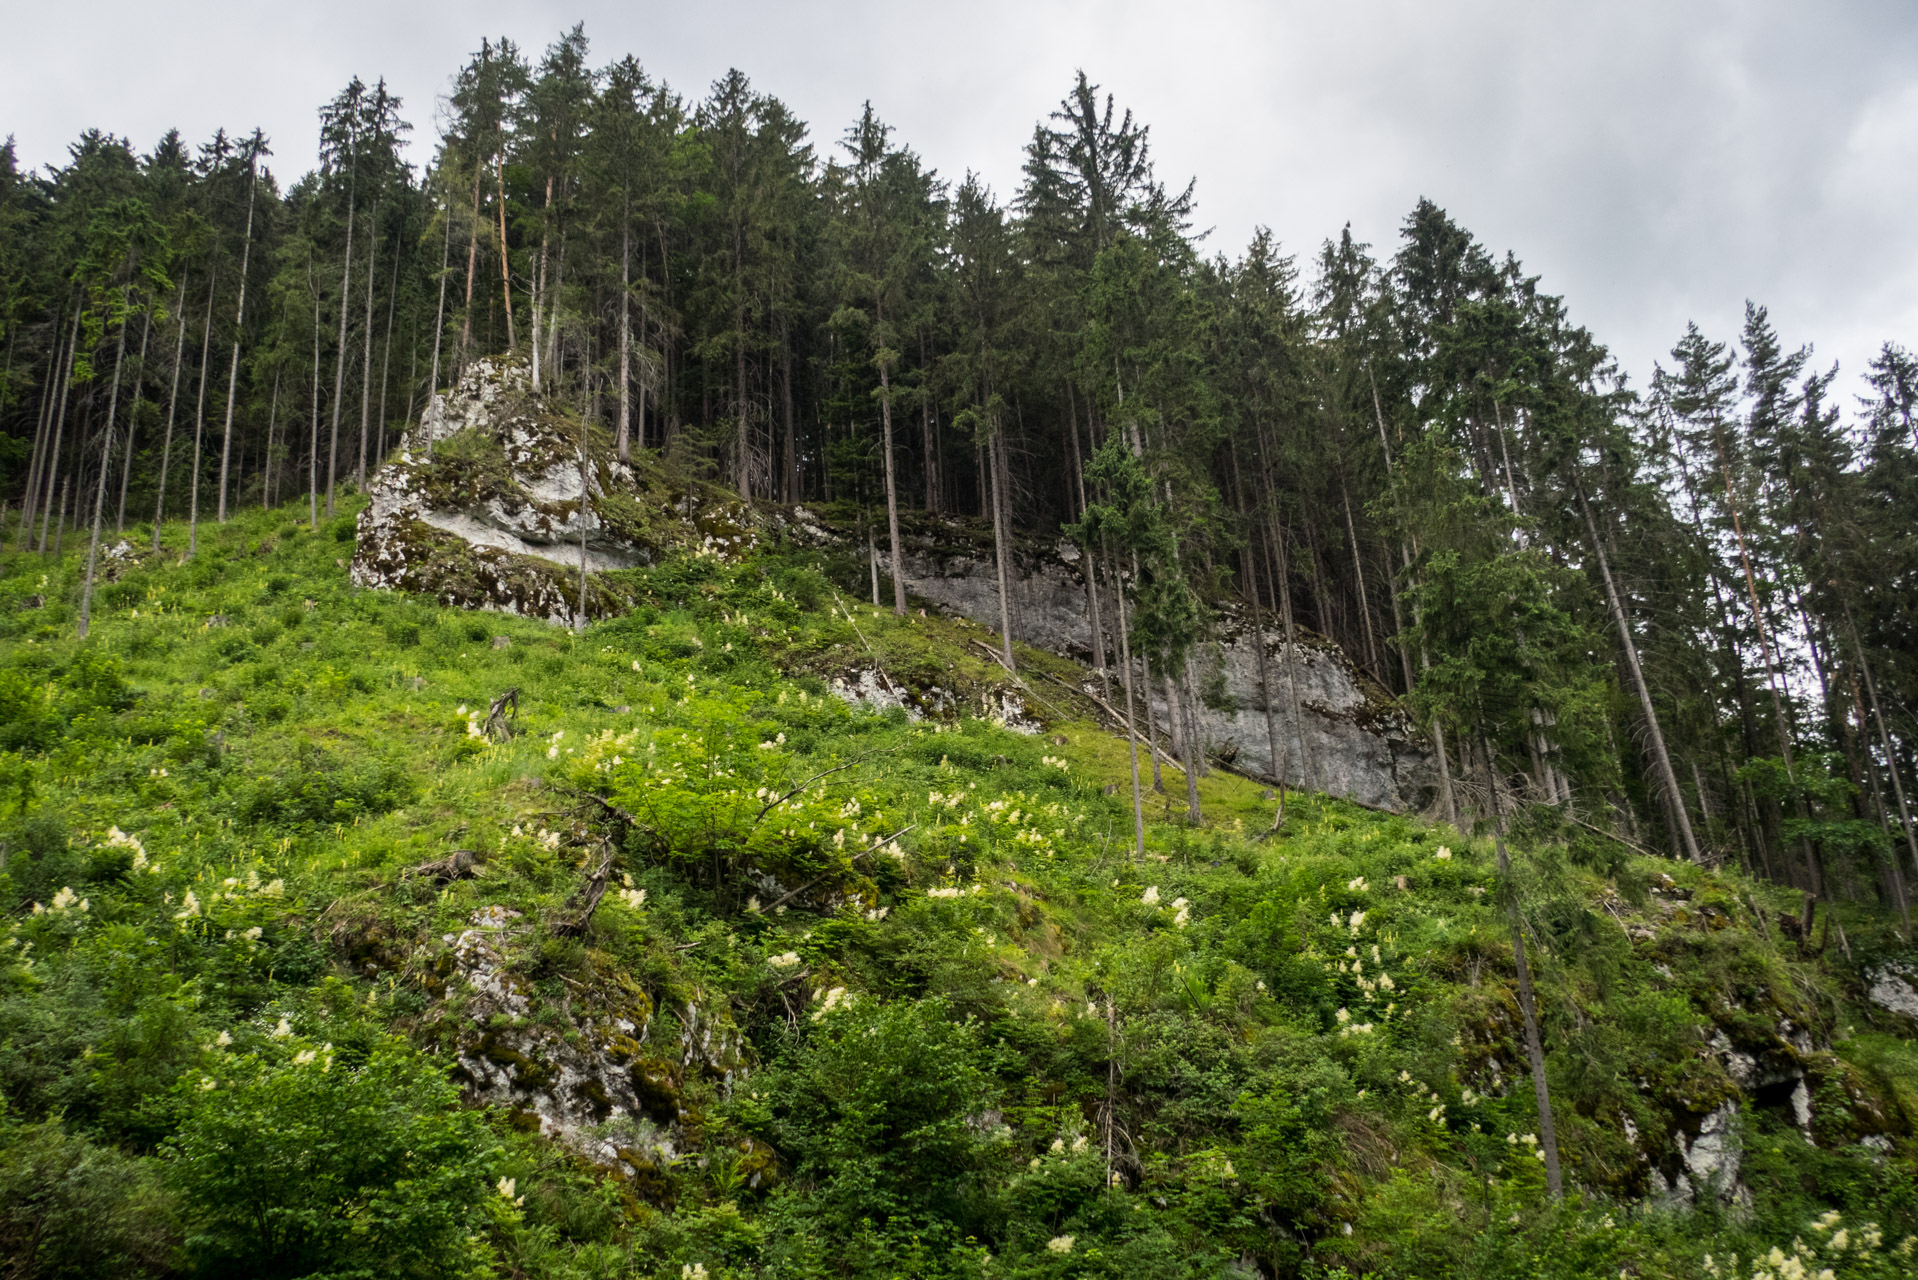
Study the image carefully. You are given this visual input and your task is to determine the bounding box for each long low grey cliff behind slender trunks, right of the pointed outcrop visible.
[905,522,1437,812]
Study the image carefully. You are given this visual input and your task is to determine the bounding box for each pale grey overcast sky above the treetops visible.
[0,0,1918,386]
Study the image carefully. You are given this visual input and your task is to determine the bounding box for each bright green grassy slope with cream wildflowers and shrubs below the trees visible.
[0,512,1918,1280]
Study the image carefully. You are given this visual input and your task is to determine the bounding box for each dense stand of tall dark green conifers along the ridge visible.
[0,29,1918,910]
